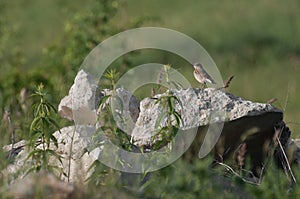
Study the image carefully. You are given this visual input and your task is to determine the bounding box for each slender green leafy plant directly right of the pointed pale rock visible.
[88,69,132,184]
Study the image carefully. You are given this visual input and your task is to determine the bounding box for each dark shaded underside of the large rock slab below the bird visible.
[188,112,282,177]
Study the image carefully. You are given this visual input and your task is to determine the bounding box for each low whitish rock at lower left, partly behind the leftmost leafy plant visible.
[2,126,96,182]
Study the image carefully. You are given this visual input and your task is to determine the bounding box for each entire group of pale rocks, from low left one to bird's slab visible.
[4,70,294,189]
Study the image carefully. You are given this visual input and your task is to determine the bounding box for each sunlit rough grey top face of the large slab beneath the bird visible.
[132,88,282,146]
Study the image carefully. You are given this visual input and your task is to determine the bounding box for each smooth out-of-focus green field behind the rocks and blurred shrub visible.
[0,0,300,134]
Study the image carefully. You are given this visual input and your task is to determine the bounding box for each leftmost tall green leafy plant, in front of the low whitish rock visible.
[27,84,62,176]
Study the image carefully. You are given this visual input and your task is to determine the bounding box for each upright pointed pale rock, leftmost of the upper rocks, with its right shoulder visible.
[58,70,139,128]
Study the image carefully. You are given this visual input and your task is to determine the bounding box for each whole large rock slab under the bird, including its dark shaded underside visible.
[132,88,283,176]
